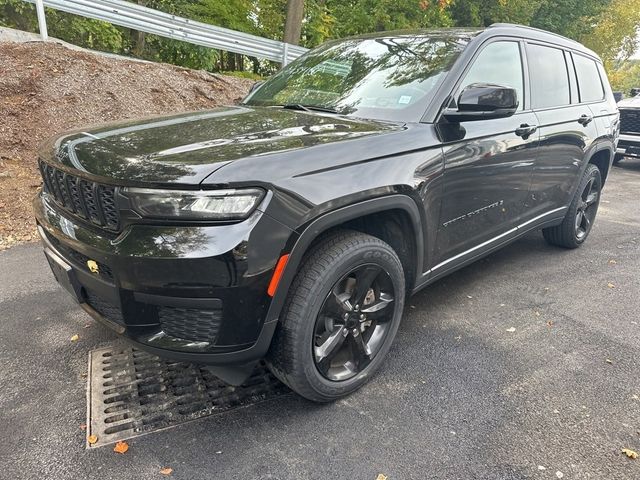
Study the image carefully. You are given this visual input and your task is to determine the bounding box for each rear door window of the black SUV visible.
[527,45,569,108]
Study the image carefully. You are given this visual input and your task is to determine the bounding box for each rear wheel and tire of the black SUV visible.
[542,164,602,248]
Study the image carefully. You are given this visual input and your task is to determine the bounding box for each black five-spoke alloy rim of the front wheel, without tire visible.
[313,264,396,381]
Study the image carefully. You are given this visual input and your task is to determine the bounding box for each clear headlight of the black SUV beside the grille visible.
[124,188,264,220]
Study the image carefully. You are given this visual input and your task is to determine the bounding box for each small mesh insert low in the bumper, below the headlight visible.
[158,307,222,343]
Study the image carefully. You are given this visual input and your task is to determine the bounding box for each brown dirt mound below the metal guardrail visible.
[0,42,253,250]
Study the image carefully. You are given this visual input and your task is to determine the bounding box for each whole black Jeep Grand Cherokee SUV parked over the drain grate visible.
[35,24,618,402]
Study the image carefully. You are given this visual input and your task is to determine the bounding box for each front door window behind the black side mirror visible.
[460,42,524,110]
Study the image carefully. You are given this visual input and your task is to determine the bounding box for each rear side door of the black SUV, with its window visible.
[527,44,604,218]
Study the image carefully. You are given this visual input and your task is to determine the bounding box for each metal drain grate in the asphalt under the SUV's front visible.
[87,347,290,448]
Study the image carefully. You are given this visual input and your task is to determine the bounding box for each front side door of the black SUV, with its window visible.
[432,40,538,270]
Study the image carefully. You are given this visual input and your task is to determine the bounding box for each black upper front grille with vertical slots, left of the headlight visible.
[39,161,120,231]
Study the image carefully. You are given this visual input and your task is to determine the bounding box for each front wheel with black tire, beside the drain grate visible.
[266,231,405,402]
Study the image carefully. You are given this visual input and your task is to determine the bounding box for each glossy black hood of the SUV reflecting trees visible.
[41,107,401,185]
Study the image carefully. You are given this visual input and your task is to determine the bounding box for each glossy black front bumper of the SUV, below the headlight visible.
[34,193,291,366]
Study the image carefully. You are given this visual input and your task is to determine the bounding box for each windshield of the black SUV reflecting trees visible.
[245,35,468,122]
